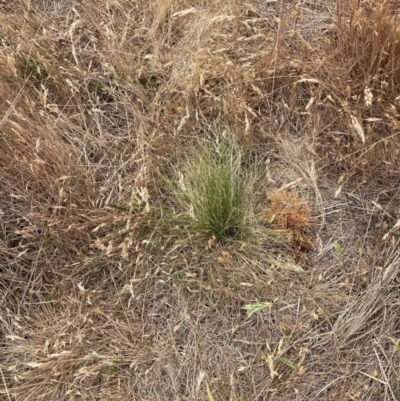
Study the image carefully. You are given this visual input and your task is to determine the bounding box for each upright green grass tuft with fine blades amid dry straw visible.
[173,140,255,242]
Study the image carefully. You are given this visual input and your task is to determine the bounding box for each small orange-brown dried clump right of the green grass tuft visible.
[265,191,310,232]
